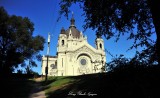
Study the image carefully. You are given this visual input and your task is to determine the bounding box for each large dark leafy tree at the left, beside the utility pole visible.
[0,7,45,75]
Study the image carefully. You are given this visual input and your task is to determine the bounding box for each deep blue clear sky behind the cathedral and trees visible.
[0,0,155,74]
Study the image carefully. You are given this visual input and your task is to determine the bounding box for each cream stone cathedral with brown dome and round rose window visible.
[42,16,106,76]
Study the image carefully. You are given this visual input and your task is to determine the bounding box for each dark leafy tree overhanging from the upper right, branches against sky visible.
[60,0,160,65]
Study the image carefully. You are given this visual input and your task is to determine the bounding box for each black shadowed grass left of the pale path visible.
[1,79,35,98]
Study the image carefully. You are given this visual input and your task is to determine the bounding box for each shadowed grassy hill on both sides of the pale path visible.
[0,66,160,98]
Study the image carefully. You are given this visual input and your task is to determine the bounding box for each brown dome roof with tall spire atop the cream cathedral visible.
[61,15,80,38]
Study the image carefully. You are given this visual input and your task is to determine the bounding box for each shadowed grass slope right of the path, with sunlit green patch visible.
[44,67,160,98]
